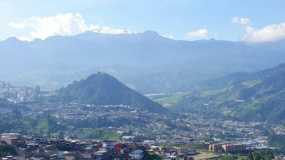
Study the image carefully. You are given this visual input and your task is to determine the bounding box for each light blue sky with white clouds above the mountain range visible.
[0,0,285,43]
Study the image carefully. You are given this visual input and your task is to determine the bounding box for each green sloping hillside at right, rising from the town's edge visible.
[174,64,285,123]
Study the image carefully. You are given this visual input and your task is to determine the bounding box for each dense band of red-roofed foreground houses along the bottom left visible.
[0,133,198,160]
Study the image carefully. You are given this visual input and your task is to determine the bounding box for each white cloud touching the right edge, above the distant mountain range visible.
[232,17,285,43]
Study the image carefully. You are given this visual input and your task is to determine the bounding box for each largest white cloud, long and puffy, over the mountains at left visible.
[9,13,130,41]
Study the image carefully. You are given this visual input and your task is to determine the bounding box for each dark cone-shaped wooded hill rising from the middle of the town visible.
[56,73,168,113]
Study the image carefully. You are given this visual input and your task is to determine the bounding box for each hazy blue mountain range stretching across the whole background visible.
[0,31,285,93]
